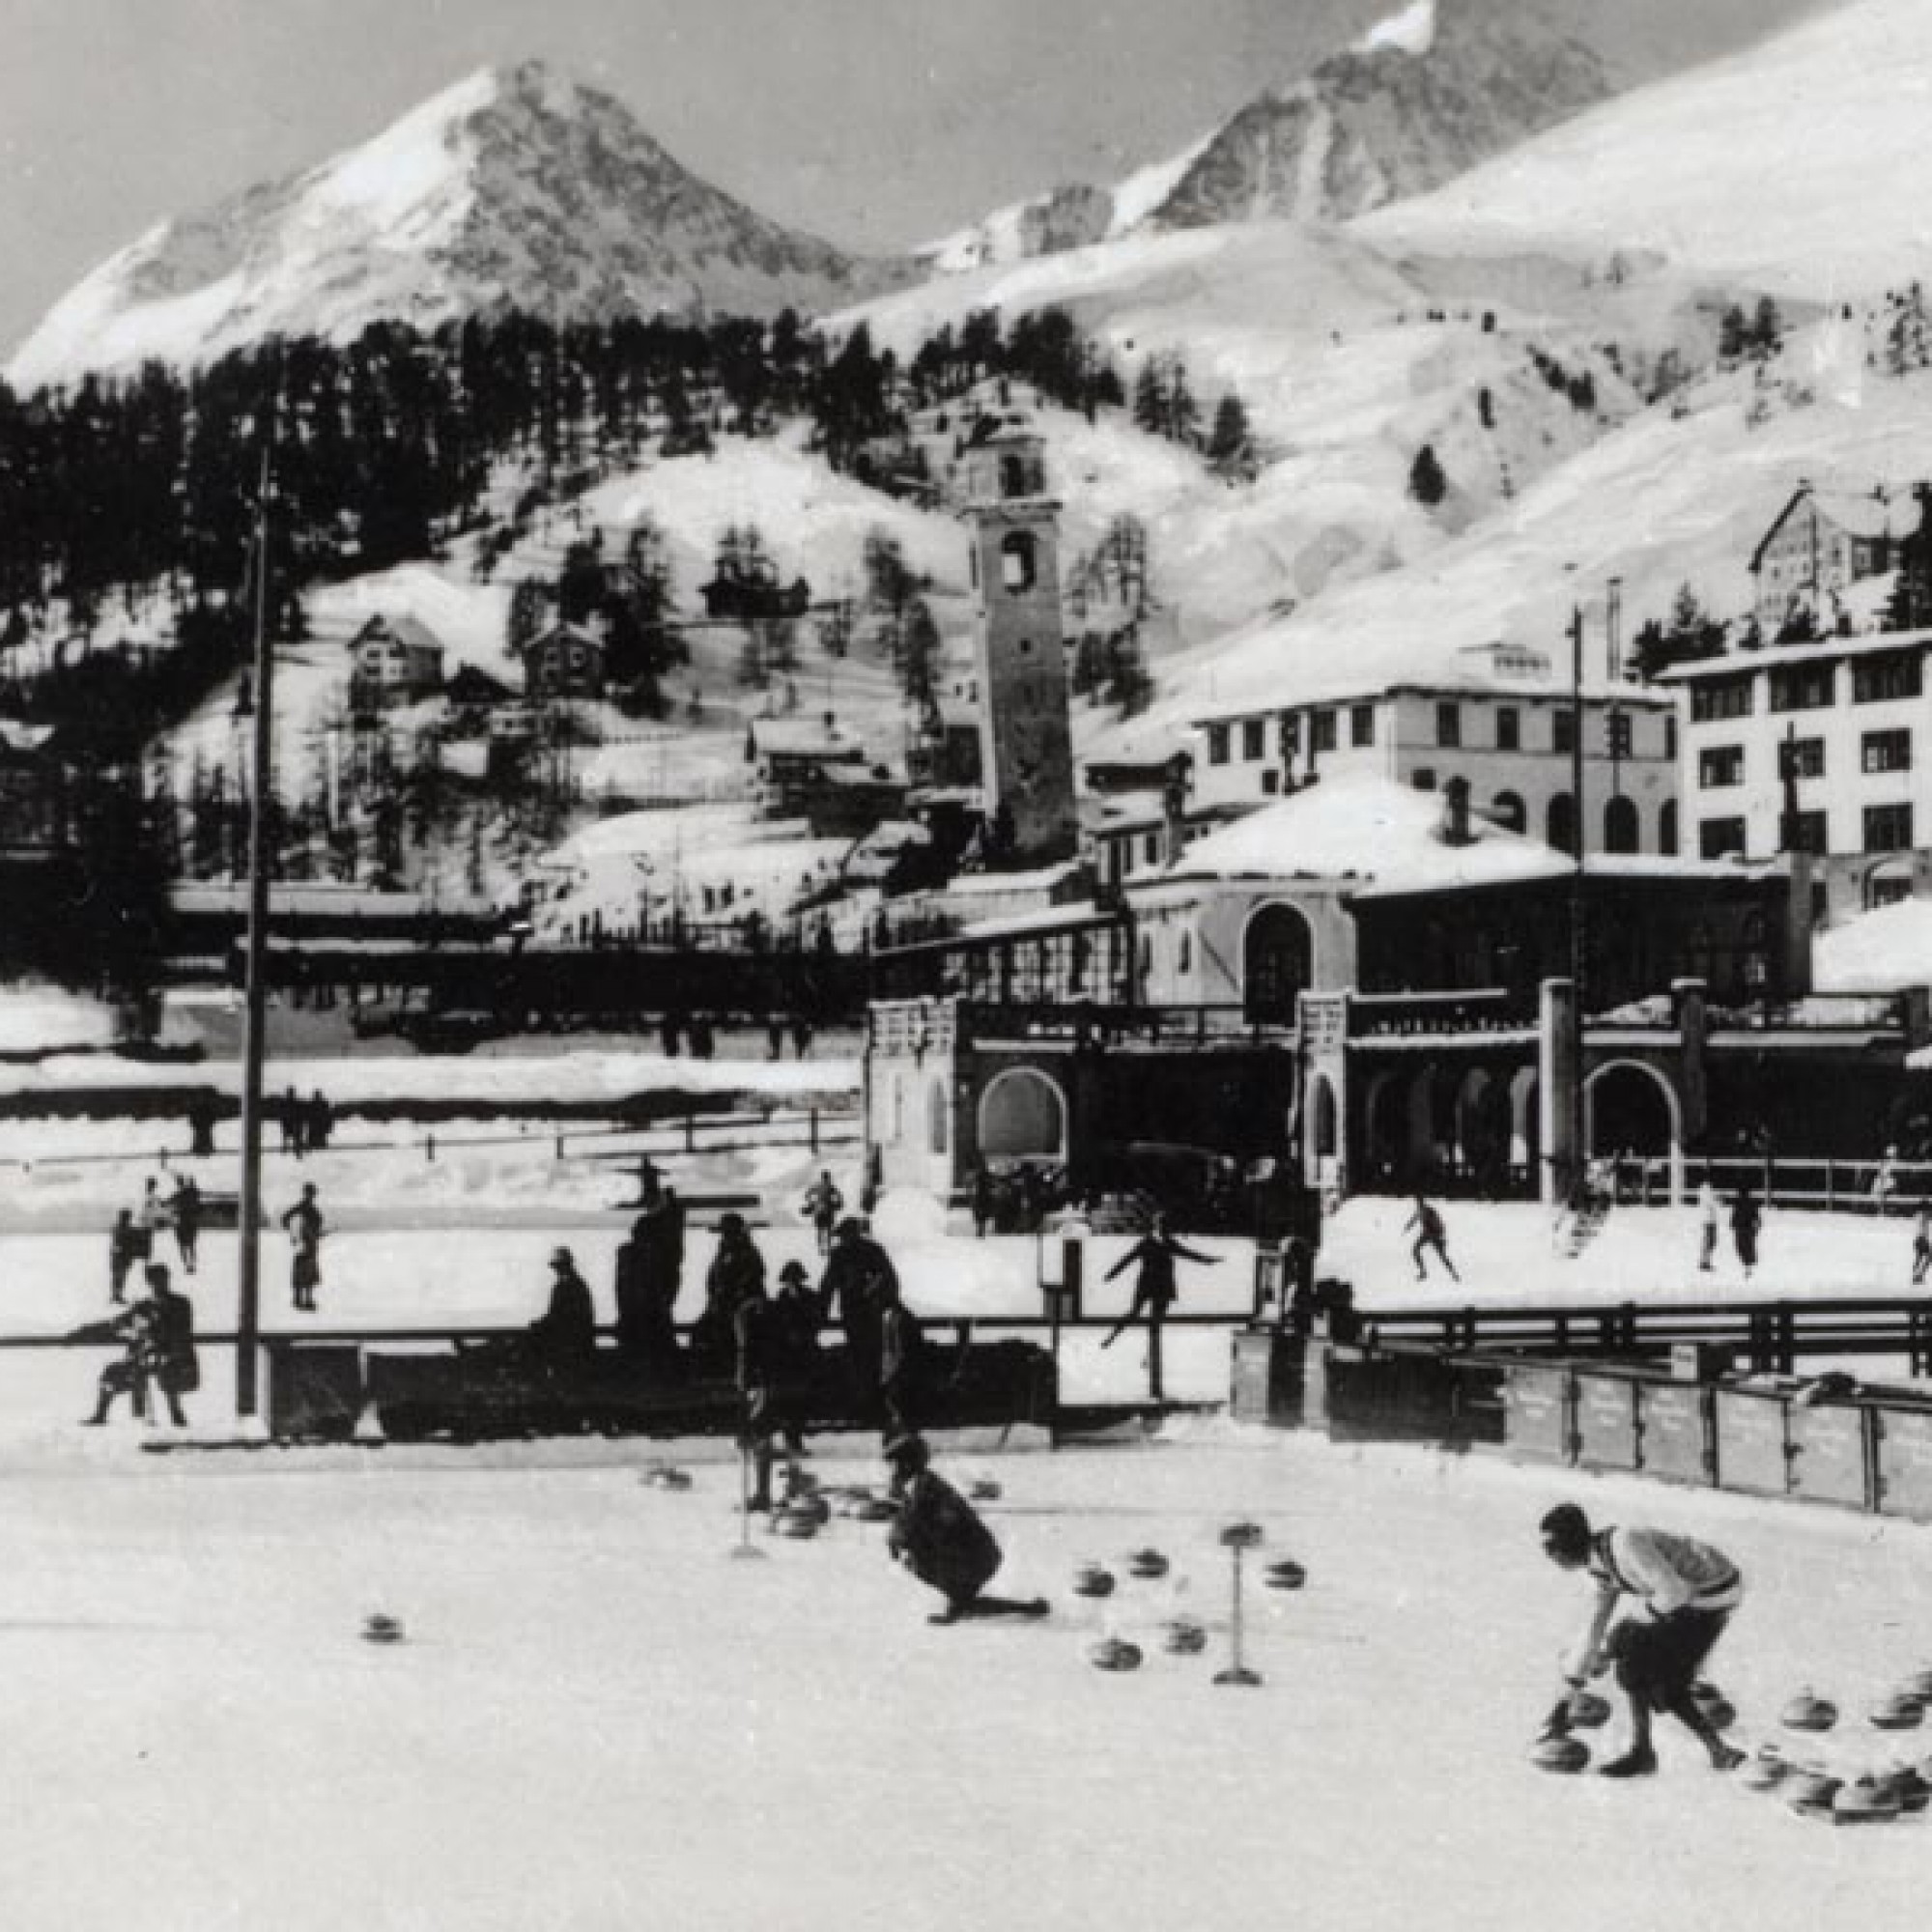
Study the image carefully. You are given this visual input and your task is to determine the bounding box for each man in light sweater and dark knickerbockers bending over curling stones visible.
[1540,1503,1745,1777]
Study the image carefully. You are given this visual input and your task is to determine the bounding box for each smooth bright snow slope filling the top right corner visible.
[1358,0,1932,296]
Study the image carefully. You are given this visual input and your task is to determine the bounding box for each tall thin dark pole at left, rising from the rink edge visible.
[236,419,274,1420]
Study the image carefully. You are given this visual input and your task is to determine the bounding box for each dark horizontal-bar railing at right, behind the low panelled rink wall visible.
[1362,1298,1932,1376]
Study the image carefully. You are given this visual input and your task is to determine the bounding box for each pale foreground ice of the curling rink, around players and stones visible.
[0,1420,1932,1932]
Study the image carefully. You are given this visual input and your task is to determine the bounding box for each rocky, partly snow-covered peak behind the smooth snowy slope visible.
[918,0,1613,272]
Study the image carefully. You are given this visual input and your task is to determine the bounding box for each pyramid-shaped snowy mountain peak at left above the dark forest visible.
[8,62,908,386]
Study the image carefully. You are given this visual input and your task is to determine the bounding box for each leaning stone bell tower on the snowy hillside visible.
[964,427,1078,866]
